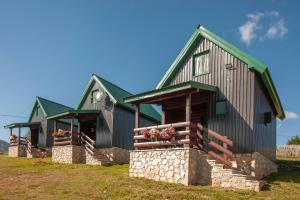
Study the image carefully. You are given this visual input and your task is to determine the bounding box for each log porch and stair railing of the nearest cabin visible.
[134,122,233,167]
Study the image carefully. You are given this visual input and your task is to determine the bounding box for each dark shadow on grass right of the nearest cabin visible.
[263,160,300,190]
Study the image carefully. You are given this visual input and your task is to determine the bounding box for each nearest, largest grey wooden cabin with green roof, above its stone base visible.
[125,26,285,164]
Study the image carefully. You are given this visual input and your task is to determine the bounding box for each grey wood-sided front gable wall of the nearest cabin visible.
[170,39,276,158]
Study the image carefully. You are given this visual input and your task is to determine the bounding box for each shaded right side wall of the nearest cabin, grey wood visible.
[253,79,276,160]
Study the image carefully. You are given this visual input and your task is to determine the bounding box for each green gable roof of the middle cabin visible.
[77,74,161,122]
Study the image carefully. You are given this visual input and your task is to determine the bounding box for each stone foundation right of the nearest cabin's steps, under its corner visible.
[232,152,277,179]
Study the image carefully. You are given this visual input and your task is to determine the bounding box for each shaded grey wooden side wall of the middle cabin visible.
[113,107,156,149]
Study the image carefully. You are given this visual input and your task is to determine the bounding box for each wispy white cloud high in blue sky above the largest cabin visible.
[238,11,288,46]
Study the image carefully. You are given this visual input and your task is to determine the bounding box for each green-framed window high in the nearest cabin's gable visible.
[193,51,209,76]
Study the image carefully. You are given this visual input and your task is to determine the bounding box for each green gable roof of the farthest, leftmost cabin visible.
[29,96,73,122]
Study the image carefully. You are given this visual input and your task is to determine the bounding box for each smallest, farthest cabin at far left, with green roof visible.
[5,97,73,157]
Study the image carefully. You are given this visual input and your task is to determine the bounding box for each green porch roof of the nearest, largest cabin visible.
[125,81,218,103]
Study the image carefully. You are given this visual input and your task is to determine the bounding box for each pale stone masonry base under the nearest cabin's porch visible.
[129,148,197,185]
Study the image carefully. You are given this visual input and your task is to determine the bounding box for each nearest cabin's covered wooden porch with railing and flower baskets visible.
[125,82,233,166]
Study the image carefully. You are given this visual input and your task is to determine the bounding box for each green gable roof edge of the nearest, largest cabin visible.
[156,26,285,119]
